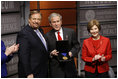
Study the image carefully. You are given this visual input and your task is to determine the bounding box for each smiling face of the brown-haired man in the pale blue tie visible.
[29,13,41,29]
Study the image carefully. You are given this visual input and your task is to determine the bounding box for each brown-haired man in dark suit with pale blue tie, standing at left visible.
[17,11,49,78]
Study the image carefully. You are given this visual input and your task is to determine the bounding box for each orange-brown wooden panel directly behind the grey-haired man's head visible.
[40,9,76,26]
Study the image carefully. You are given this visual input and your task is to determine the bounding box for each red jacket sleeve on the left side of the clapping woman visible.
[82,41,93,62]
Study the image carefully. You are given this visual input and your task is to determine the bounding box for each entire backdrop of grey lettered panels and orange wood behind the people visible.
[1,1,117,78]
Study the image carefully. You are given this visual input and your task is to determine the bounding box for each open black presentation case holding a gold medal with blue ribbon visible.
[56,40,70,62]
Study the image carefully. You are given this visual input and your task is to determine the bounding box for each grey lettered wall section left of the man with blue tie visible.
[1,1,22,76]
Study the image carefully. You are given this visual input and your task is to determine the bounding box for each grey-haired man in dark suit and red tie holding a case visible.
[46,13,80,78]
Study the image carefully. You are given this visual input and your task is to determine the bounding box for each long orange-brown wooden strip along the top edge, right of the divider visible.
[40,1,76,9]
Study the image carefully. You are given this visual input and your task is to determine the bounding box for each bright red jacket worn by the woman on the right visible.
[82,36,112,73]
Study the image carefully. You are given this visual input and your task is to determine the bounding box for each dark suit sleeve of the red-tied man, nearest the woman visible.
[71,30,80,56]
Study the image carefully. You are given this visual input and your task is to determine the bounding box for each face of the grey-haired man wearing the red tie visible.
[50,16,62,31]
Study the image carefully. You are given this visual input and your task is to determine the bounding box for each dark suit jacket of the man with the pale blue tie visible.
[17,25,49,77]
